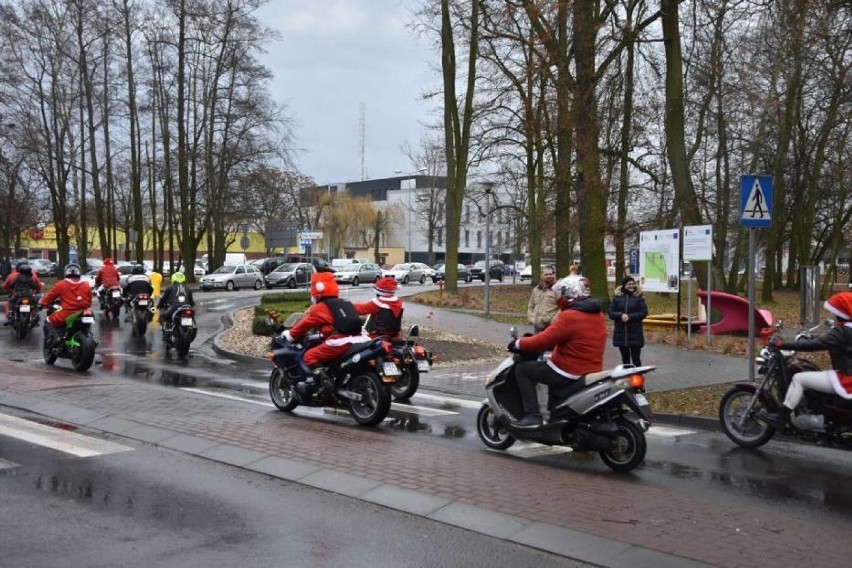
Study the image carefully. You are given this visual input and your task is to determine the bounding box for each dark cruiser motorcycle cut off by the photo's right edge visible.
[719,320,852,450]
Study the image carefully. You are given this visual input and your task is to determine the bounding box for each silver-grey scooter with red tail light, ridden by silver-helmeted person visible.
[476,328,656,472]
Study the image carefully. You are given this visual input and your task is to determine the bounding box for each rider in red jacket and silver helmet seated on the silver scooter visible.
[508,276,607,427]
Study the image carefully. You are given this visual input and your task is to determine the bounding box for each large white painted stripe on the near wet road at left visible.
[0,414,133,458]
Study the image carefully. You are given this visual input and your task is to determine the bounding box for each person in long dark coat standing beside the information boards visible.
[609,276,648,367]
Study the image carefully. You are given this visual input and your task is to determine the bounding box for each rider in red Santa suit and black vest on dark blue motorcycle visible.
[281,272,370,392]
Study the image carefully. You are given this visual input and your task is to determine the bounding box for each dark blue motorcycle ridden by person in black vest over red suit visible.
[267,313,395,426]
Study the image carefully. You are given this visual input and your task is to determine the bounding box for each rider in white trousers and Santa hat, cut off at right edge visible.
[763,292,852,429]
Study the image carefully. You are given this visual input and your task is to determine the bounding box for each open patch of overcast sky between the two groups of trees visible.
[258,0,439,184]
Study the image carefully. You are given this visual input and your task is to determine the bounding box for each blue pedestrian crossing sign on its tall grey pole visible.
[740,175,772,382]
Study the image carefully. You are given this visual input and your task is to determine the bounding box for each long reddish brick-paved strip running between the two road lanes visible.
[0,363,852,568]
